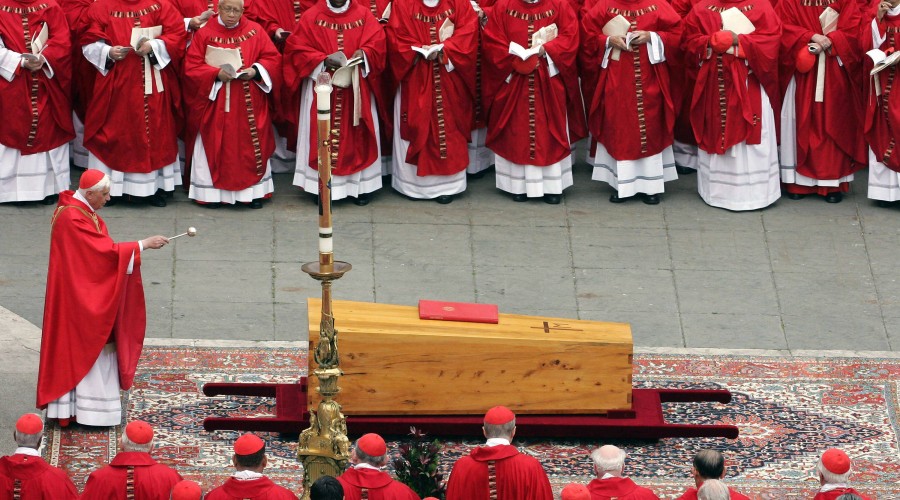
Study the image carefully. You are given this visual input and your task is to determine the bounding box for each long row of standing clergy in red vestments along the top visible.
[0,0,900,210]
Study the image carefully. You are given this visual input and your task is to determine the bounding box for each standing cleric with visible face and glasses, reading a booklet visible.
[184,0,281,208]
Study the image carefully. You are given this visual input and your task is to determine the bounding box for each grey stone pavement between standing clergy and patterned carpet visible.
[0,166,900,448]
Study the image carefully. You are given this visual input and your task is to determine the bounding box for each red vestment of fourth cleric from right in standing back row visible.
[581,0,681,160]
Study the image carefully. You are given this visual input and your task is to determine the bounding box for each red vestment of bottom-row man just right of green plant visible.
[447,445,553,500]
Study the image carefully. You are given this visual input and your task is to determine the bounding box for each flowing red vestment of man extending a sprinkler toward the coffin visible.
[37,191,147,408]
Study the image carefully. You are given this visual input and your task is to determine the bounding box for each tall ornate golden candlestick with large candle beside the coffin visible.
[297,72,352,500]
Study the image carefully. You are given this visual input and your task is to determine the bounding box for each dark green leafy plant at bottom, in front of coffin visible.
[391,427,446,499]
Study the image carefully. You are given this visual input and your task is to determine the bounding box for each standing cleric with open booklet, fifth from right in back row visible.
[482,0,586,204]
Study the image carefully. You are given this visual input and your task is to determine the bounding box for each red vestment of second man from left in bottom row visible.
[81,451,181,500]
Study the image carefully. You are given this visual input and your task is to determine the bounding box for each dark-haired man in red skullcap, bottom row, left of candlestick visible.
[206,432,297,500]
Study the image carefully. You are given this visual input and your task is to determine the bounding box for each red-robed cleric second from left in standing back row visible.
[78,0,186,207]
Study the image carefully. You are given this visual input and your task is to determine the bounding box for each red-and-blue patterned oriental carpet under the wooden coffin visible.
[43,346,900,500]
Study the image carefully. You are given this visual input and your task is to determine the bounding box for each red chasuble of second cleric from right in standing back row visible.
[778,0,871,179]
